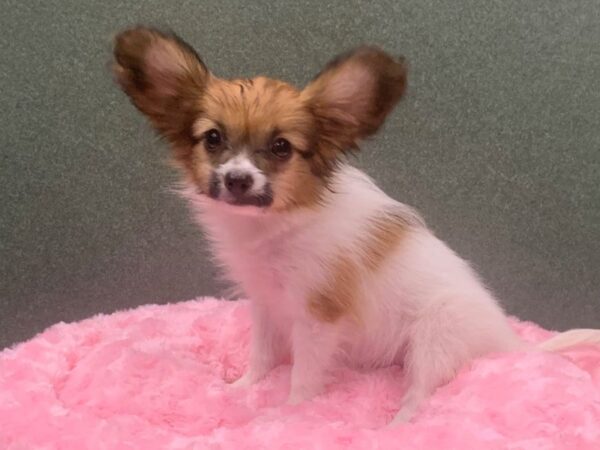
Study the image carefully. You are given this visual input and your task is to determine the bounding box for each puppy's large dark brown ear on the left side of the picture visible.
[113,26,210,146]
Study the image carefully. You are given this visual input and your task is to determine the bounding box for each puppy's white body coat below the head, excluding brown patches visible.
[179,166,597,422]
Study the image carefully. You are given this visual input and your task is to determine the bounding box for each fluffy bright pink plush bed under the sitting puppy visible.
[0,299,600,450]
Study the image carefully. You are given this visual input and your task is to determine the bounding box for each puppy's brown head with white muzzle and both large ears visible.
[114,27,406,211]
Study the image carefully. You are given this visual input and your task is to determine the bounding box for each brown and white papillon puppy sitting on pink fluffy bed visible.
[114,27,600,422]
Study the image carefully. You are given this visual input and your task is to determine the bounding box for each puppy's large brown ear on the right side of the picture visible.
[302,47,407,151]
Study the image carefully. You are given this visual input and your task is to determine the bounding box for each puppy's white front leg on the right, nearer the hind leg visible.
[288,320,339,405]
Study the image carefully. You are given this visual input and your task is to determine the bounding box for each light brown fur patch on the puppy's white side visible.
[308,211,414,323]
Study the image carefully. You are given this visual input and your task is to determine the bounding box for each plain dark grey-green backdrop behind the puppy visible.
[0,0,600,347]
